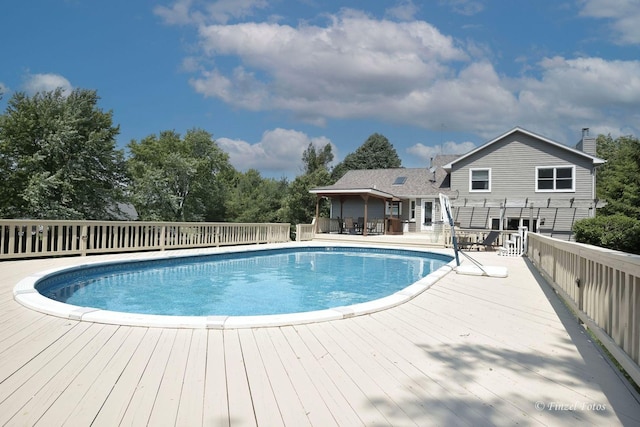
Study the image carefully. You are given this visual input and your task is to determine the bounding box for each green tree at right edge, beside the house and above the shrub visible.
[596,135,640,219]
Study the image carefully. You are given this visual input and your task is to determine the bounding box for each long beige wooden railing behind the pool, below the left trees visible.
[0,219,290,259]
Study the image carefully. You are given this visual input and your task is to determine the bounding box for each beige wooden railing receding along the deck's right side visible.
[527,233,640,384]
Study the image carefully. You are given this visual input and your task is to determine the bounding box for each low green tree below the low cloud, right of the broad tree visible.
[226,169,289,223]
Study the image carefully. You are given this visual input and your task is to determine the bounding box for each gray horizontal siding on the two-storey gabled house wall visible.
[451,132,594,239]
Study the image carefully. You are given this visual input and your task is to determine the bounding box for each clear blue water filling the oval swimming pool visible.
[36,247,452,316]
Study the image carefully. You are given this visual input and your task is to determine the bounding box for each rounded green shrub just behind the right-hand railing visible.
[573,214,640,254]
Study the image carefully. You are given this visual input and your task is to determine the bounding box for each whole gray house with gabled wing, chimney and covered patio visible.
[311,127,605,240]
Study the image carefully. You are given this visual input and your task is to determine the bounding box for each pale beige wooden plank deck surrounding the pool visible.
[0,246,640,427]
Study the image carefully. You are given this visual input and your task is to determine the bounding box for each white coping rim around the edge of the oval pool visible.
[13,242,455,329]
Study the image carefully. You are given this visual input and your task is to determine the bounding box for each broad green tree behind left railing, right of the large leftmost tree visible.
[127,129,233,221]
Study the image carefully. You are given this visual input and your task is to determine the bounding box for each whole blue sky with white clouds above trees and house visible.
[0,0,640,178]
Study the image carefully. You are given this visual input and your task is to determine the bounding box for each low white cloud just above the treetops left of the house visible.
[216,128,335,176]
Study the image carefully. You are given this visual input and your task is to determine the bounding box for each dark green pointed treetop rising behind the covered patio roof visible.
[331,133,402,182]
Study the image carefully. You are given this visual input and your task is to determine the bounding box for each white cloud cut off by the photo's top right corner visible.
[580,0,640,44]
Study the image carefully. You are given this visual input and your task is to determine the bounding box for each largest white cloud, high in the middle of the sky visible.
[192,10,468,122]
